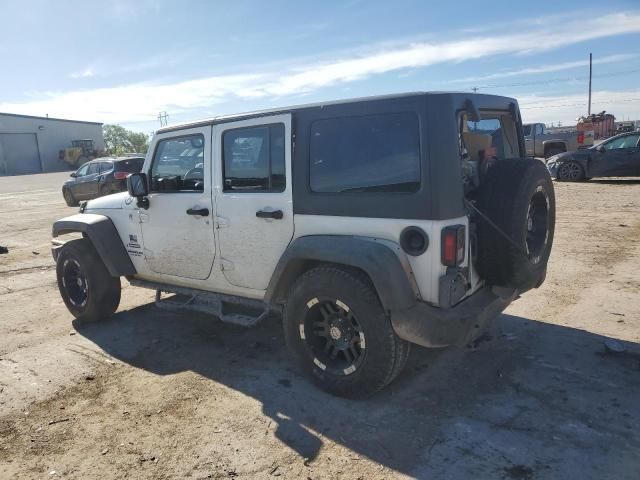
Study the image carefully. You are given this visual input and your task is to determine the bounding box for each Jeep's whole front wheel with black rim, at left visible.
[56,239,120,321]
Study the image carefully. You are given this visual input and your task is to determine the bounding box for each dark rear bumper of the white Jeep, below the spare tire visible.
[391,287,518,347]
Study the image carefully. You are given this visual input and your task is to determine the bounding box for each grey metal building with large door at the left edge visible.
[0,113,104,175]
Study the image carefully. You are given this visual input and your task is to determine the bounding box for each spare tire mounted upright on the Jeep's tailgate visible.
[476,159,556,292]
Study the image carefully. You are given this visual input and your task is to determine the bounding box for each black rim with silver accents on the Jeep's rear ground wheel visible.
[299,297,366,376]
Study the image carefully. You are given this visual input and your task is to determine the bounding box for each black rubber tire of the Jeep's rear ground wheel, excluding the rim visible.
[283,265,410,398]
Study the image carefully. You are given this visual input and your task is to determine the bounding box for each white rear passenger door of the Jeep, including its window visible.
[214,114,293,290]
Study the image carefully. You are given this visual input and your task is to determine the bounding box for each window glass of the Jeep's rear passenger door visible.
[222,123,286,192]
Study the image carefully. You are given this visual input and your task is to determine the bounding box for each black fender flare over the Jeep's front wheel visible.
[52,213,136,277]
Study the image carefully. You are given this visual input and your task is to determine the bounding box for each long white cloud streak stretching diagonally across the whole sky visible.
[0,12,640,122]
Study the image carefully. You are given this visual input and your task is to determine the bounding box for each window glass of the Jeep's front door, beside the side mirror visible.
[151,134,204,192]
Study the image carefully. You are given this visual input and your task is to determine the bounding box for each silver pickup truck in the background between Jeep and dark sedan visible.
[522,123,593,158]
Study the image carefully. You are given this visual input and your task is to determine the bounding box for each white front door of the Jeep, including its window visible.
[139,126,216,280]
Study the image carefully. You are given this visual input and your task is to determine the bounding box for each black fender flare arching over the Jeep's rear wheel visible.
[264,235,418,311]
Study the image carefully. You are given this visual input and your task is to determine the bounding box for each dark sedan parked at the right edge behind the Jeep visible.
[547,132,640,182]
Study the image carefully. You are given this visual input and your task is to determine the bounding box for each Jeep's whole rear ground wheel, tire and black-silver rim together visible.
[284,266,409,398]
